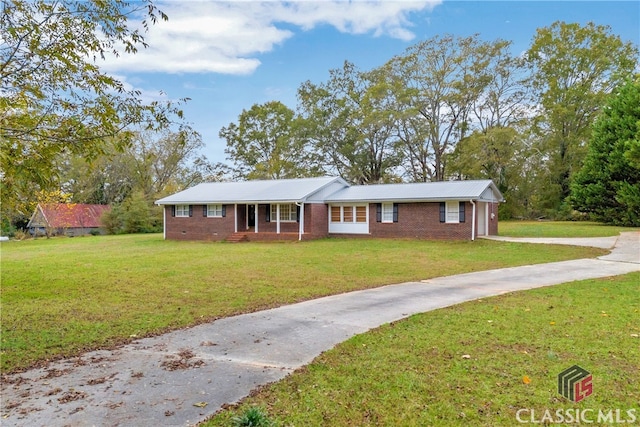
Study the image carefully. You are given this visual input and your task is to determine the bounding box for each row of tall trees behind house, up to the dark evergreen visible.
[219,22,638,224]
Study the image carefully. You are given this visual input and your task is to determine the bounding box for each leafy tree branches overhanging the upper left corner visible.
[0,0,190,224]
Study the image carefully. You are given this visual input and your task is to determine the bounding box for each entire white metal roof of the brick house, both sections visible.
[156,177,503,205]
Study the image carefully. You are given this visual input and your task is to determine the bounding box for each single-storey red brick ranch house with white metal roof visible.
[156,177,503,241]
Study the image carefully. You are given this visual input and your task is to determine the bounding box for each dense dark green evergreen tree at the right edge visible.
[571,75,640,226]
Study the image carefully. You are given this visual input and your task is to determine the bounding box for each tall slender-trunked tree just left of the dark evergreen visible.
[526,22,638,211]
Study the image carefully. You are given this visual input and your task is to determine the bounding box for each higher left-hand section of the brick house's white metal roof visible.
[156,177,348,205]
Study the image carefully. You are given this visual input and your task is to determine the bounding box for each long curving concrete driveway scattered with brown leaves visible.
[1,233,640,427]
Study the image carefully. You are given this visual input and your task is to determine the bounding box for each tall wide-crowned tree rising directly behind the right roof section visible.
[386,35,509,181]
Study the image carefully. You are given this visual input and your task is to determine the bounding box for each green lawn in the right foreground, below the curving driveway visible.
[204,273,640,427]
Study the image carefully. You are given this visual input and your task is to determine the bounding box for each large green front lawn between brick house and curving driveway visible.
[0,235,604,372]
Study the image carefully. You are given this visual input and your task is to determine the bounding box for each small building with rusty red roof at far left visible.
[27,203,110,236]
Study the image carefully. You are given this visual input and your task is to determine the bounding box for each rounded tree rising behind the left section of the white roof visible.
[220,101,319,179]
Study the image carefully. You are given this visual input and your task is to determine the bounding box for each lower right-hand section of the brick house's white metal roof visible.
[326,180,503,203]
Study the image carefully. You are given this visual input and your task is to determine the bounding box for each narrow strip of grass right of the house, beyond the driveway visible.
[498,221,640,237]
